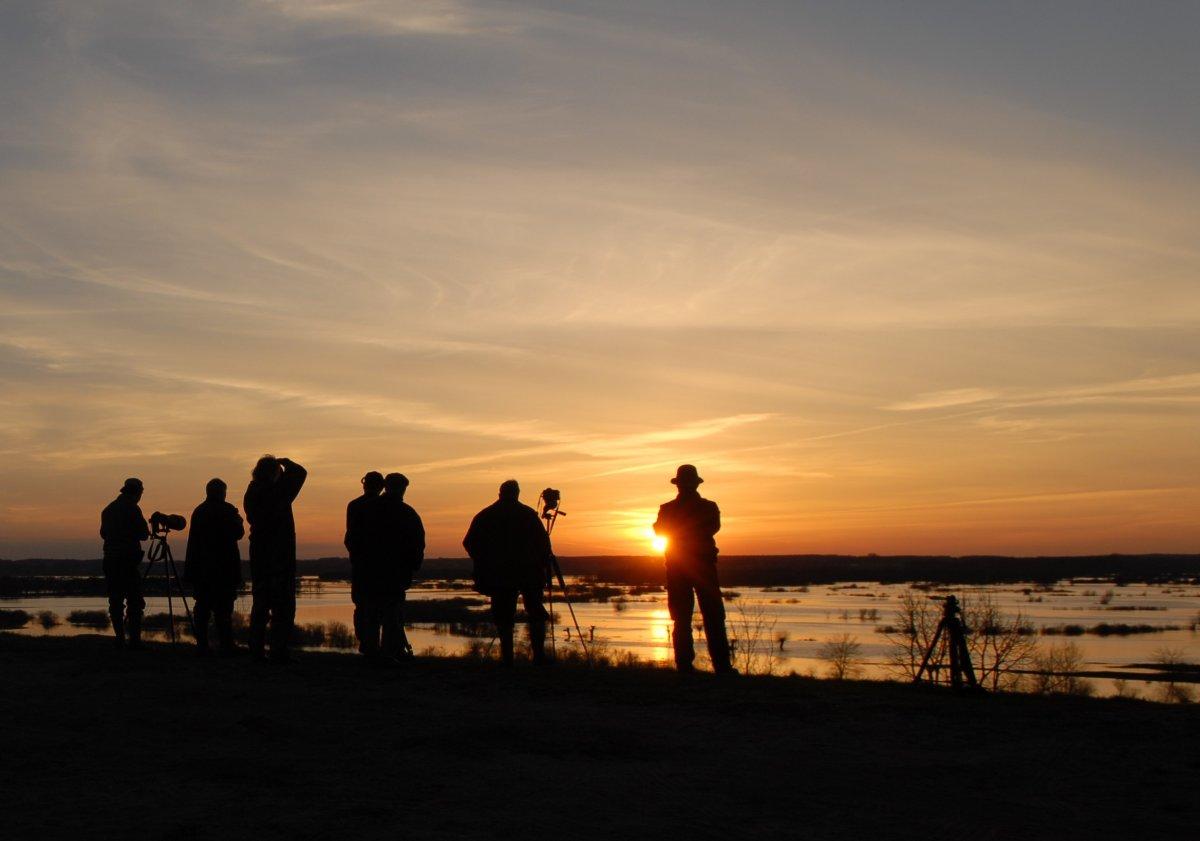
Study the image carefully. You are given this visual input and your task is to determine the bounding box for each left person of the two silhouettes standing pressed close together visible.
[344,470,388,663]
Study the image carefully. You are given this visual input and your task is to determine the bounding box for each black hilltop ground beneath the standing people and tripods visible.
[0,633,1200,841]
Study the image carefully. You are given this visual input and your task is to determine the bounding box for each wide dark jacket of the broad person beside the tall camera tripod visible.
[462,499,551,595]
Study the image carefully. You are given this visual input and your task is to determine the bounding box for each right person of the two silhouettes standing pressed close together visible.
[379,473,425,661]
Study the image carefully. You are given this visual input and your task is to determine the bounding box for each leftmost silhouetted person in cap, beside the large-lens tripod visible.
[100,479,150,648]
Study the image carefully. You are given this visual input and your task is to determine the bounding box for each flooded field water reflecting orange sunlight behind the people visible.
[0,581,1200,693]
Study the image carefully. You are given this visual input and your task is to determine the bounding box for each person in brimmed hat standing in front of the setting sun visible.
[654,464,736,673]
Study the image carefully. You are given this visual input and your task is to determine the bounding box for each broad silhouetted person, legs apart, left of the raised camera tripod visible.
[462,479,551,666]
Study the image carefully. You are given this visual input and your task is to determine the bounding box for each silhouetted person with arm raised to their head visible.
[242,456,308,662]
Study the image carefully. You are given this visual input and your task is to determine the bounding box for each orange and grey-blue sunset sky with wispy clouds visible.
[0,0,1200,558]
